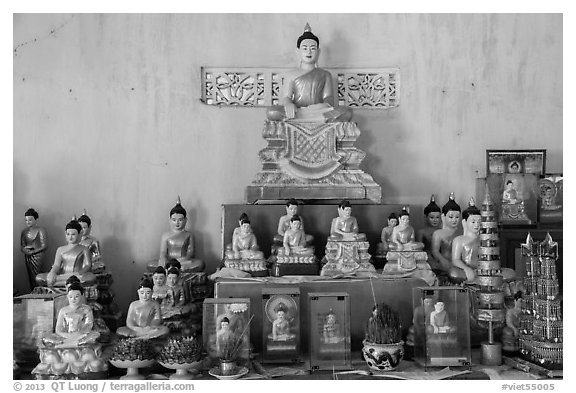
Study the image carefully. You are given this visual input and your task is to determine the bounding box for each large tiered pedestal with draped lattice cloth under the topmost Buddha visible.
[246,120,382,203]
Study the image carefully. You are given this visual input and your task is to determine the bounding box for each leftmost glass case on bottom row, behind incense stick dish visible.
[202,298,250,367]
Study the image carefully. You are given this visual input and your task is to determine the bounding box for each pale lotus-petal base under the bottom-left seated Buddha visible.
[32,344,108,379]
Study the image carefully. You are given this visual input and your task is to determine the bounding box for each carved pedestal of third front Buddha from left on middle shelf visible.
[320,240,376,276]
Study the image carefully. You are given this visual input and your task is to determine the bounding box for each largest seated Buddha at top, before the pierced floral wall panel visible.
[267,24,352,123]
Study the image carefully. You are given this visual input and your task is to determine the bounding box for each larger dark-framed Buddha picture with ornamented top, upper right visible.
[486,150,546,226]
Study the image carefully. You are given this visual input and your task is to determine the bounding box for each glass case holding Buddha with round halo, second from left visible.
[262,287,302,363]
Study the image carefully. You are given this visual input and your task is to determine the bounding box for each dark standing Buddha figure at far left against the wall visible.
[20,208,48,289]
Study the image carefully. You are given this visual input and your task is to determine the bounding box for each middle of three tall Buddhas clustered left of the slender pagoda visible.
[431,192,462,274]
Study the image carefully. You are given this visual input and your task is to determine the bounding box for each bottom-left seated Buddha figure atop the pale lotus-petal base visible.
[42,276,100,348]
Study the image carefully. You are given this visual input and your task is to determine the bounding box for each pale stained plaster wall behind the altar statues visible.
[13,14,563,309]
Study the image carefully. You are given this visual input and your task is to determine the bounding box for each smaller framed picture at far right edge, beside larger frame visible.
[538,174,564,224]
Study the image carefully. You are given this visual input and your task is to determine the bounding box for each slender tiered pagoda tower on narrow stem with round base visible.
[476,188,506,366]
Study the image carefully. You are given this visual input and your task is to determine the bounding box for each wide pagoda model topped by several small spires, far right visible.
[519,233,563,370]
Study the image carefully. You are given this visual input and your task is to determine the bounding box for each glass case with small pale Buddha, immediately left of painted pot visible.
[308,292,352,371]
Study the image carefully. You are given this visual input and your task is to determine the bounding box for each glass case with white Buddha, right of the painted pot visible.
[412,287,471,368]
